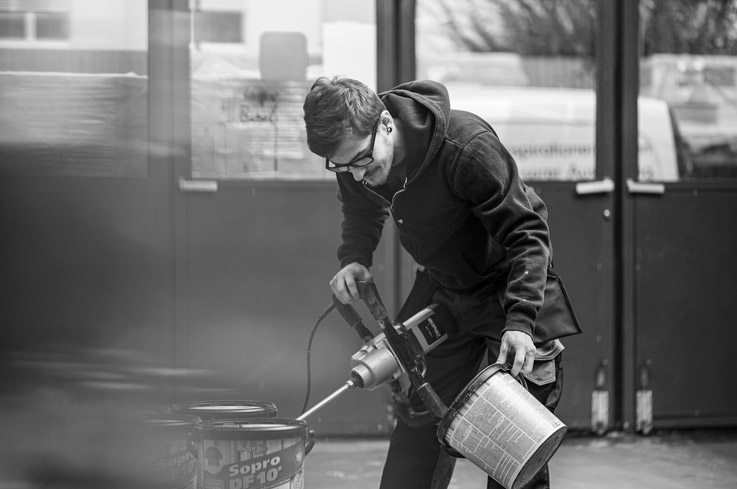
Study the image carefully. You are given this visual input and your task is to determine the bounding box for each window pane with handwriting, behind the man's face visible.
[191,0,376,180]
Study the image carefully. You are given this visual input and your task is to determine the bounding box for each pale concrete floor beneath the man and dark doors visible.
[305,433,737,489]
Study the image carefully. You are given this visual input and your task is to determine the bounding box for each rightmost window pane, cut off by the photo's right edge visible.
[640,0,737,180]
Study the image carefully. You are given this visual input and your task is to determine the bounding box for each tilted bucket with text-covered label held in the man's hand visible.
[438,364,567,489]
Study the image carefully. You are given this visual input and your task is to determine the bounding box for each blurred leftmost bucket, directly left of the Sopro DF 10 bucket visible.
[145,414,200,489]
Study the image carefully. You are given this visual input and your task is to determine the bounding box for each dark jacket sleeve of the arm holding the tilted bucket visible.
[449,131,551,335]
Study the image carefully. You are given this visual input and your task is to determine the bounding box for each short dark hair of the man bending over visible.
[303,76,385,157]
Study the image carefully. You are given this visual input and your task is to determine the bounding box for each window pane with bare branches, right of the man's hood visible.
[416,0,596,181]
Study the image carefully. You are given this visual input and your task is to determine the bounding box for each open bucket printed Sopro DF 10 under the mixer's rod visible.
[195,418,315,489]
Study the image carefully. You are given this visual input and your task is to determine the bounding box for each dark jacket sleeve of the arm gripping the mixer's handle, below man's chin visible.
[337,173,389,267]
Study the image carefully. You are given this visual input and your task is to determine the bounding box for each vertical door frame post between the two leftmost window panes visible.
[148,0,191,396]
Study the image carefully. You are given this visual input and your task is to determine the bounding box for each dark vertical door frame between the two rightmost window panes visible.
[596,0,640,431]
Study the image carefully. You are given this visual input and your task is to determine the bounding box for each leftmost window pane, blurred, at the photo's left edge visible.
[0,0,148,177]
